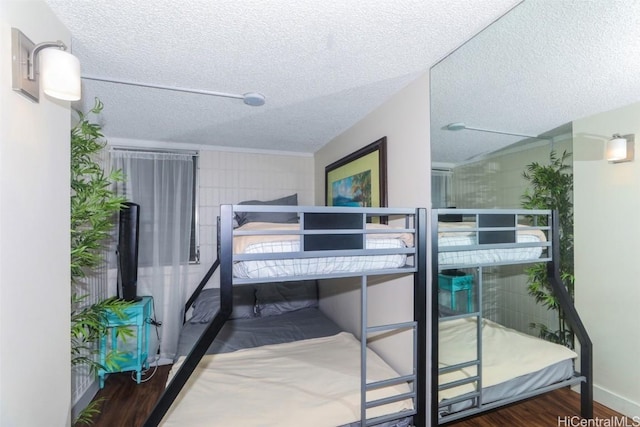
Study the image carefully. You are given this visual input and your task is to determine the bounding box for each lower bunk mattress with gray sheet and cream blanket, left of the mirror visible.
[168,308,413,427]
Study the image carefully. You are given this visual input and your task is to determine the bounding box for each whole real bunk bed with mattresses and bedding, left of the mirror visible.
[144,204,429,427]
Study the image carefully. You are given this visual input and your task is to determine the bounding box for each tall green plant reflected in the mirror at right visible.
[522,150,575,347]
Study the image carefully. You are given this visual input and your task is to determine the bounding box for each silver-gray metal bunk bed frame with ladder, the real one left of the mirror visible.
[143,205,433,427]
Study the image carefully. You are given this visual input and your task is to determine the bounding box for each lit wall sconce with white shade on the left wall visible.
[11,28,81,102]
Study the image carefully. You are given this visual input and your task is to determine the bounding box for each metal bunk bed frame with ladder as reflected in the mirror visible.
[430,209,593,426]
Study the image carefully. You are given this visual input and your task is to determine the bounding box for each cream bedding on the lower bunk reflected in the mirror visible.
[438,318,577,400]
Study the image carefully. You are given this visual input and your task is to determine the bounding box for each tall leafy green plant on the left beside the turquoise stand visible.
[71,99,131,424]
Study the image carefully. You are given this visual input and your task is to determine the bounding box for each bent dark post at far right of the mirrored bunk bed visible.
[547,211,593,419]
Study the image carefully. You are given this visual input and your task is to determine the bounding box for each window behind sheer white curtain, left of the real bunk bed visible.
[112,150,199,267]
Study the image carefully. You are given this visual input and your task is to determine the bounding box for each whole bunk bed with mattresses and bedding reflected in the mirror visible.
[431,209,593,425]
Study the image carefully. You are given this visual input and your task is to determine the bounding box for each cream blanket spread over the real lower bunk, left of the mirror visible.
[162,332,413,427]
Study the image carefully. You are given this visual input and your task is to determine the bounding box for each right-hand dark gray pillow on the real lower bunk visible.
[256,281,318,316]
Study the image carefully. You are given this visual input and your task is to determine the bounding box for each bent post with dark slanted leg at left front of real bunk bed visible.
[143,205,233,427]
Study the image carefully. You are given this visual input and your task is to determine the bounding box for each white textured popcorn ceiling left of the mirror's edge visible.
[46,0,520,153]
